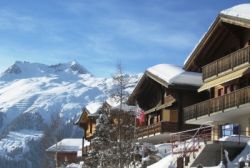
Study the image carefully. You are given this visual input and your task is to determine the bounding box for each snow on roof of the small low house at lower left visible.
[47,138,89,152]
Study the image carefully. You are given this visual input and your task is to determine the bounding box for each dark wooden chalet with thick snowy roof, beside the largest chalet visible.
[128,64,206,143]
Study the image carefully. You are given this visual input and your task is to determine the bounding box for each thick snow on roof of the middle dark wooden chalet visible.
[147,64,202,86]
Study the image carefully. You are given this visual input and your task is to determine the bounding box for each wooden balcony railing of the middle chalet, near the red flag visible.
[136,121,178,138]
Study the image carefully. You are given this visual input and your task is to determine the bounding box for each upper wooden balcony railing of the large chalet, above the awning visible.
[202,46,250,80]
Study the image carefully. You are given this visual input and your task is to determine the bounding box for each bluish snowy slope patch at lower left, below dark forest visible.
[0,130,43,159]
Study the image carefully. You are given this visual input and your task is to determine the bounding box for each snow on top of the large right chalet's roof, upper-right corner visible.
[220,3,250,20]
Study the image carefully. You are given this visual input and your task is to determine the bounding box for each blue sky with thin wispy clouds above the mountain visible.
[0,0,249,76]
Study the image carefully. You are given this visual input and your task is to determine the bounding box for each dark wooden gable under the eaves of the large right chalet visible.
[184,14,250,72]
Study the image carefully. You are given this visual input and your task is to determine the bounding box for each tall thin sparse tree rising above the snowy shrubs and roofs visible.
[112,64,138,168]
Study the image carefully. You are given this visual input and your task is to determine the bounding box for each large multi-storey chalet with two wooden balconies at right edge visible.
[184,4,250,140]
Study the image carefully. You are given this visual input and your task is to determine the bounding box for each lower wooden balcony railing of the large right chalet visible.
[184,86,250,121]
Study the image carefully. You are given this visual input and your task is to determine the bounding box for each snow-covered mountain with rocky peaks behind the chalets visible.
[0,61,141,167]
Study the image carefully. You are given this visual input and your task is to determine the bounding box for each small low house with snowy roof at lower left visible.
[46,138,89,167]
